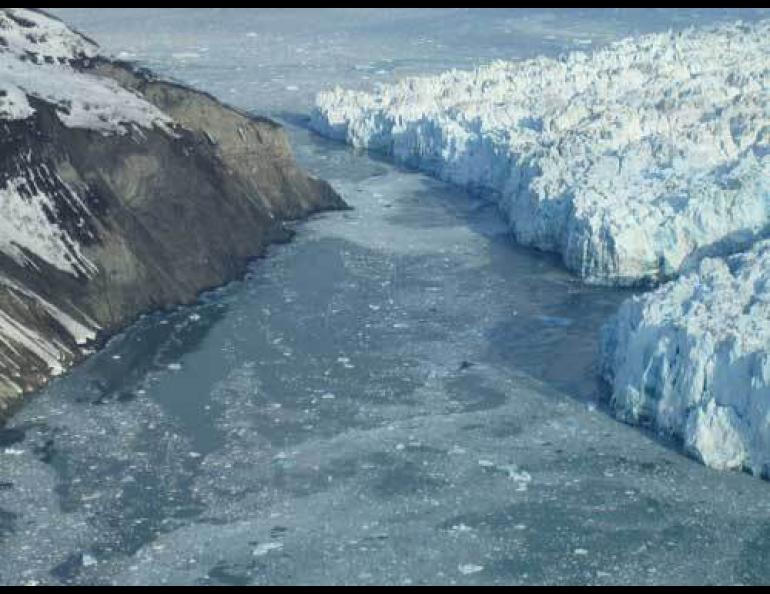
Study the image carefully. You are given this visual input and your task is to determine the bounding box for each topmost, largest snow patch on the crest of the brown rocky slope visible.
[0,9,171,134]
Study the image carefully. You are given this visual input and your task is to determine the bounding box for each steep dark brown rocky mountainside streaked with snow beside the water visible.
[0,9,344,415]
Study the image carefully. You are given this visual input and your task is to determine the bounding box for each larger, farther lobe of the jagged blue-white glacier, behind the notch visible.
[312,21,770,284]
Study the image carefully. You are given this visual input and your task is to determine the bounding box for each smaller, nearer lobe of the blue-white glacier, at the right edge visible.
[602,241,770,476]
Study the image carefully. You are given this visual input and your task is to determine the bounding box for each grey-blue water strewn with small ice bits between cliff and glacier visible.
[0,10,770,584]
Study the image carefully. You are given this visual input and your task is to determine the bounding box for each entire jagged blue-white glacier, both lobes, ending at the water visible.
[312,21,770,475]
